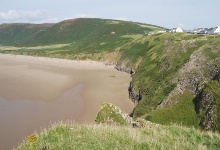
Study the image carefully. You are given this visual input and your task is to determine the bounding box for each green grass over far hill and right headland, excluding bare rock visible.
[0,19,220,130]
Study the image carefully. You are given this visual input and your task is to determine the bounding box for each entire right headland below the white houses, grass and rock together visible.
[133,33,220,131]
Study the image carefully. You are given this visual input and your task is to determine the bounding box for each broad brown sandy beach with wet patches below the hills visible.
[0,54,134,149]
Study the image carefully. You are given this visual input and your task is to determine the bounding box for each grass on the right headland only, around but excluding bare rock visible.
[133,34,220,127]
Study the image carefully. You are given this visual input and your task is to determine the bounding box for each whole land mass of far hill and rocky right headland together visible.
[0,19,220,131]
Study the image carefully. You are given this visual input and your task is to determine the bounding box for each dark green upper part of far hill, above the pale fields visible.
[0,18,162,46]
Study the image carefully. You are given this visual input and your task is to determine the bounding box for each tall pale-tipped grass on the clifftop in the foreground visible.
[17,123,220,150]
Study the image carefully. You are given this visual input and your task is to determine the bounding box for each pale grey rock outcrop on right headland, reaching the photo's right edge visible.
[161,46,220,106]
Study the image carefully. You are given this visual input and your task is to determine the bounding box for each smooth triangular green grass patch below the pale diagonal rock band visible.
[148,93,199,128]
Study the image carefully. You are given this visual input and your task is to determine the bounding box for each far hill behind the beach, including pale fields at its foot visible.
[0,19,161,60]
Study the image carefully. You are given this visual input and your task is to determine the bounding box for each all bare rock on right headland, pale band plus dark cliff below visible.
[158,45,220,131]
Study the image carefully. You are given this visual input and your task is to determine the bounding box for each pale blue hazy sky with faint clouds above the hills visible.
[0,0,220,29]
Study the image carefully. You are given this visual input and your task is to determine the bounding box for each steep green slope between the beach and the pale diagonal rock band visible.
[133,34,203,116]
